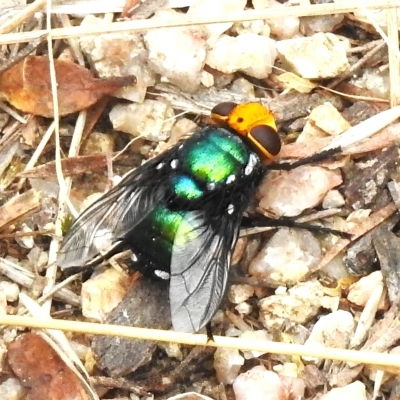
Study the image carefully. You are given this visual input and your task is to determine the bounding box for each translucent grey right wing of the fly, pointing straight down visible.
[169,211,241,332]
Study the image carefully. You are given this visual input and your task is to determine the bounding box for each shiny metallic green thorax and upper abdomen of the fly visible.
[135,128,251,265]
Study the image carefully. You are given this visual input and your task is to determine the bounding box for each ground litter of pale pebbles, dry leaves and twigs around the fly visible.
[0,0,400,400]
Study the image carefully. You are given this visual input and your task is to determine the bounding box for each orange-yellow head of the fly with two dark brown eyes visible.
[211,102,281,163]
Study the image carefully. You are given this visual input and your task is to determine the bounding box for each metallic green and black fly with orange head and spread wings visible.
[57,102,340,332]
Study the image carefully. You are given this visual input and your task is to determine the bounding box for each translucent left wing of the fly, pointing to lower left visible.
[57,149,174,268]
